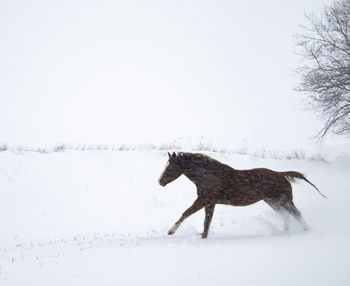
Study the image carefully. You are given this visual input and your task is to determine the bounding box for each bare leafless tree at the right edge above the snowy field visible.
[296,0,350,139]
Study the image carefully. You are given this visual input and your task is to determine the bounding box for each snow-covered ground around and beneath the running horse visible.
[0,151,350,286]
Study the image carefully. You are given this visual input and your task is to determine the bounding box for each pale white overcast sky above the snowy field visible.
[0,0,338,148]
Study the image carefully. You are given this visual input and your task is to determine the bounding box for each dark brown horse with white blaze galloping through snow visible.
[159,153,325,238]
